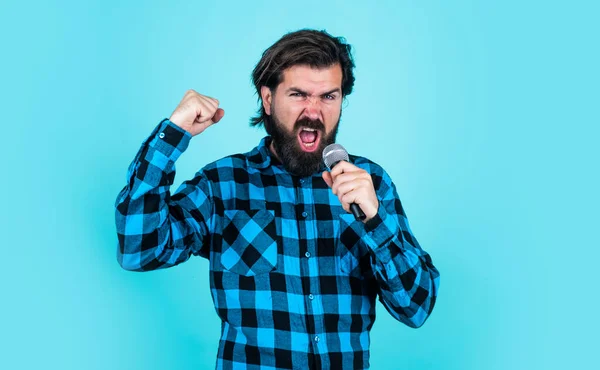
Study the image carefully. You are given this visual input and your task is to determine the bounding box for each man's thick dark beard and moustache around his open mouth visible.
[264,106,341,177]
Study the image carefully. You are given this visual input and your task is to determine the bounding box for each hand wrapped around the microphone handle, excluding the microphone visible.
[322,161,379,222]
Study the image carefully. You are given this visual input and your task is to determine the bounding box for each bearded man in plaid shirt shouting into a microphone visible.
[116,30,439,369]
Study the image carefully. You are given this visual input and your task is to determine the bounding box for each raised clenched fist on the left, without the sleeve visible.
[169,90,225,136]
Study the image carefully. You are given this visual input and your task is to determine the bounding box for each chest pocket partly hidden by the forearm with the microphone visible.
[336,213,373,278]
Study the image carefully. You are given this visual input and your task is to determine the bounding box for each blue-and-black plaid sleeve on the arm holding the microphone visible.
[364,173,440,328]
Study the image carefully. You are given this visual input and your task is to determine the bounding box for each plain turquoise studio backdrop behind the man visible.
[0,1,600,370]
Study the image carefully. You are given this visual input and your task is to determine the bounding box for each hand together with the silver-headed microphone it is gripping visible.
[323,144,379,222]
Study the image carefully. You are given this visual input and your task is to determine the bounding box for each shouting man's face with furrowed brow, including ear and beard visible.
[261,64,342,176]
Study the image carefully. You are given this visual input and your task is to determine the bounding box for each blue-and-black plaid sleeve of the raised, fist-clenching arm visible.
[115,119,213,271]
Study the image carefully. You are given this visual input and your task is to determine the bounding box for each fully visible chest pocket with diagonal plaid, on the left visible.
[221,209,277,276]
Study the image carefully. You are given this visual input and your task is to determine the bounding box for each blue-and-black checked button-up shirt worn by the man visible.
[116,119,439,369]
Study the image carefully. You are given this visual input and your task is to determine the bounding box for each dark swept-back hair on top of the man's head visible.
[250,29,354,131]
